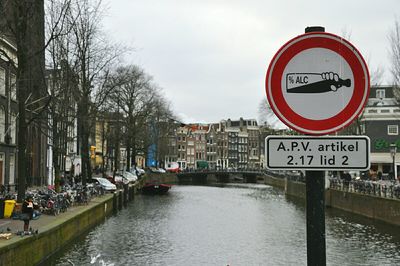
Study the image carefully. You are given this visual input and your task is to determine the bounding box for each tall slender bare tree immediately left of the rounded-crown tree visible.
[64,0,123,184]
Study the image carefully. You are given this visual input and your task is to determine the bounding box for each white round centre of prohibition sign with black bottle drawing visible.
[281,48,354,120]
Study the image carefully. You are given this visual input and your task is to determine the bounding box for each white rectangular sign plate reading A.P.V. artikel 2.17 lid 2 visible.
[265,136,370,170]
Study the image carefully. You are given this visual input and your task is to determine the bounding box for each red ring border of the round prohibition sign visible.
[266,32,369,135]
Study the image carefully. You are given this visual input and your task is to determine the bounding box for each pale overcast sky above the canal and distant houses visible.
[104,0,400,123]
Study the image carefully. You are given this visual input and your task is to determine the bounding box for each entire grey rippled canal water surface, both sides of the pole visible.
[48,184,400,266]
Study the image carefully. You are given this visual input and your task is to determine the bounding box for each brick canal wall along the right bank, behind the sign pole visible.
[265,176,400,226]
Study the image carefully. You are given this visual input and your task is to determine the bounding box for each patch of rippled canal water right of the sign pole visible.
[326,209,400,265]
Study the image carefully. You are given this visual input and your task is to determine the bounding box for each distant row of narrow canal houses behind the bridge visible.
[164,118,276,169]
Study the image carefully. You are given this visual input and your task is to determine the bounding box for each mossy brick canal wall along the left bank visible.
[0,186,136,266]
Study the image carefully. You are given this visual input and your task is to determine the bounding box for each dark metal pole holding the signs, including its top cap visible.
[305,27,326,266]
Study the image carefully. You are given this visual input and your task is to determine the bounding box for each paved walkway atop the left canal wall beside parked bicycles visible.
[0,194,113,248]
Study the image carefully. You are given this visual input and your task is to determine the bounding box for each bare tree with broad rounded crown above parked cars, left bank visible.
[104,65,172,170]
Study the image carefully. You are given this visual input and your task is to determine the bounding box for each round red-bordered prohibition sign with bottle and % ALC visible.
[265,32,370,135]
